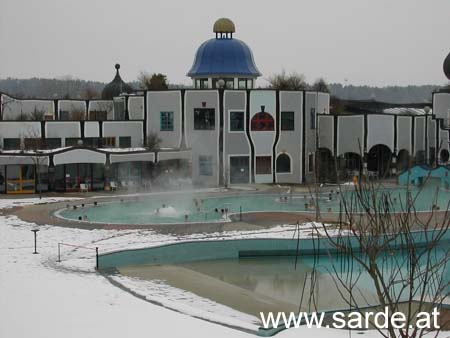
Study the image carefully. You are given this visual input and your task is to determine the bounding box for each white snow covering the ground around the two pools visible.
[0,198,396,338]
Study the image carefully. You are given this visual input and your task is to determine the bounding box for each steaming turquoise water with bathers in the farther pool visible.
[59,182,450,224]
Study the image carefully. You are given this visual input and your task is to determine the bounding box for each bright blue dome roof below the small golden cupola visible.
[187,38,261,77]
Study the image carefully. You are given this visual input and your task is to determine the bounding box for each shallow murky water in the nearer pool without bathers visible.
[119,248,450,317]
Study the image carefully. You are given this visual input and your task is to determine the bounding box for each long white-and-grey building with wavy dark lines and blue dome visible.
[0,19,450,193]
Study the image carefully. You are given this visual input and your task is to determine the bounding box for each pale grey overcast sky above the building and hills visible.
[0,0,450,86]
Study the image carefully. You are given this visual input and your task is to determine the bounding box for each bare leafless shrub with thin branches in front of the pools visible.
[300,165,450,338]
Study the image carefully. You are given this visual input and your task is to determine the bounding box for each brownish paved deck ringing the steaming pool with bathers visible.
[3,182,448,235]
